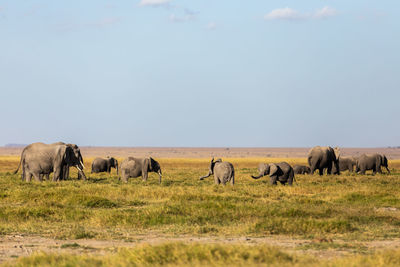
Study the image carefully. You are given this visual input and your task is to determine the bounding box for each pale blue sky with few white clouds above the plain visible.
[0,0,400,147]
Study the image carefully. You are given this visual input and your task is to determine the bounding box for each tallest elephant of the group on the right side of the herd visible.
[308,146,340,175]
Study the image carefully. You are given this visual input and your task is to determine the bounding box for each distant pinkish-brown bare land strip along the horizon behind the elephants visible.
[0,146,400,159]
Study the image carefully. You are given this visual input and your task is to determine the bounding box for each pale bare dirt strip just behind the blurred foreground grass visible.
[0,234,400,263]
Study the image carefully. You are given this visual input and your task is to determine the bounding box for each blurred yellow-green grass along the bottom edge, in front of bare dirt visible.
[4,243,400,267]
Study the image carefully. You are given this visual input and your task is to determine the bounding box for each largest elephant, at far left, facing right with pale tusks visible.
[14,143,83,182]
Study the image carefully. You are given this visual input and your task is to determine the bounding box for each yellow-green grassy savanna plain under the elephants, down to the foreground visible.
[0,148,400,266]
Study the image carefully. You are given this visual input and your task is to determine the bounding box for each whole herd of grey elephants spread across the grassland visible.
[14,142,390,185]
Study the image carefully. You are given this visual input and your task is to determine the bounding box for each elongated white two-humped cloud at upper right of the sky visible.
[264,6,337,20]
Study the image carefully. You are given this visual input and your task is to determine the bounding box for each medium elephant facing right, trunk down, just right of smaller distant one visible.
[121,157,162,184]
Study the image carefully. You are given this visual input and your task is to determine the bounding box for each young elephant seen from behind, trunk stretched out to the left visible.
[200,158,235,185]
